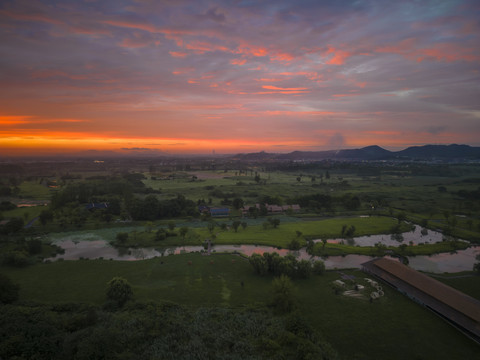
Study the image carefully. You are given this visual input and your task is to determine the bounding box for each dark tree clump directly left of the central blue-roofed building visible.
[127,195,198,221]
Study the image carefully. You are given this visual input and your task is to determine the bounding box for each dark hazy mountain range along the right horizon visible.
[235,144,480,161]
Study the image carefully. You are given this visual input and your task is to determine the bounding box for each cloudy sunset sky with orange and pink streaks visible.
[0,0,480,156]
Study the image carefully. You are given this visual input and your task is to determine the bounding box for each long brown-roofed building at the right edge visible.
[362,258,480,342]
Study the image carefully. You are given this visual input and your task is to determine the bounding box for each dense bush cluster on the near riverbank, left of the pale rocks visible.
[248,252,325,279]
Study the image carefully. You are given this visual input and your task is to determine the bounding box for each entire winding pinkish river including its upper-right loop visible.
[47,227,480,273]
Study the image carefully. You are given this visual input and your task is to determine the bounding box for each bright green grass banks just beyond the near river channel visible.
[111,216,469,256]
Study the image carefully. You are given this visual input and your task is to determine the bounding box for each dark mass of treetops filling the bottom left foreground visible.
[0,303,339,360]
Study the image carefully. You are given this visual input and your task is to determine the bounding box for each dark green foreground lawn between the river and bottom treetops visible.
[2,254,479,359]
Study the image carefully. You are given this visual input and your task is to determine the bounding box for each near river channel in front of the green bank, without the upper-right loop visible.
[47,234,480,273]
